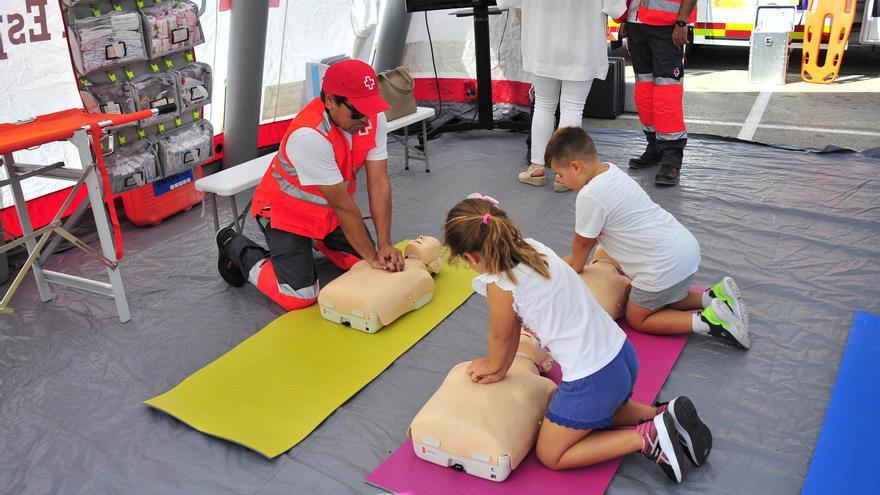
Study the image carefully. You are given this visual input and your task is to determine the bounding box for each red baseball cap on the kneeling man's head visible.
[321,59,391,115]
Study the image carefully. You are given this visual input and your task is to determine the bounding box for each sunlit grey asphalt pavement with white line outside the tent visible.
[584,46,880,150]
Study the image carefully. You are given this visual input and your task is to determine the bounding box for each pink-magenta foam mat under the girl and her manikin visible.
[365,322,688,495]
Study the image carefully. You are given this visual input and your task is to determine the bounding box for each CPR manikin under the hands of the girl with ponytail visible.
[409,332,556,481]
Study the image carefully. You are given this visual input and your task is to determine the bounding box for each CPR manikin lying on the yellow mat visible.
[318,236,440,333]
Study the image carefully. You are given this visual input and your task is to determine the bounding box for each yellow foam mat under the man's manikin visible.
[144,244,475,458]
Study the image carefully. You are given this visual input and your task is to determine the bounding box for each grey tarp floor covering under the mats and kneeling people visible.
[0,131,880,495]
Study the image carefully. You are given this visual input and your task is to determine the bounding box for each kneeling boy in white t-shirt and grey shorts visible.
[545,127,751,349]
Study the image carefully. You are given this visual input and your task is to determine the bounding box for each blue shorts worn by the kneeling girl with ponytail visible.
[547,339,639,430]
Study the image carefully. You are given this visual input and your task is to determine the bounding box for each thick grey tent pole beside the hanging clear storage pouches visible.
[223,0,269,168]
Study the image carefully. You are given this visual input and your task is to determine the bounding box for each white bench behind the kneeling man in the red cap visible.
[195,107,434,232]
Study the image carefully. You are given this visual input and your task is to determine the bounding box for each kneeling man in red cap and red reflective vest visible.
[217,60,404,311]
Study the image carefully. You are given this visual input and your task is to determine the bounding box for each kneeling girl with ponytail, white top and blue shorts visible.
[443,194,712,482]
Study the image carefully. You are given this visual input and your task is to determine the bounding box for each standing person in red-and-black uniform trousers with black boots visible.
[619,0,697,186]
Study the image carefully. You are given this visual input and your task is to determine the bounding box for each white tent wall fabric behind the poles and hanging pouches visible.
[0,0,526,232]
